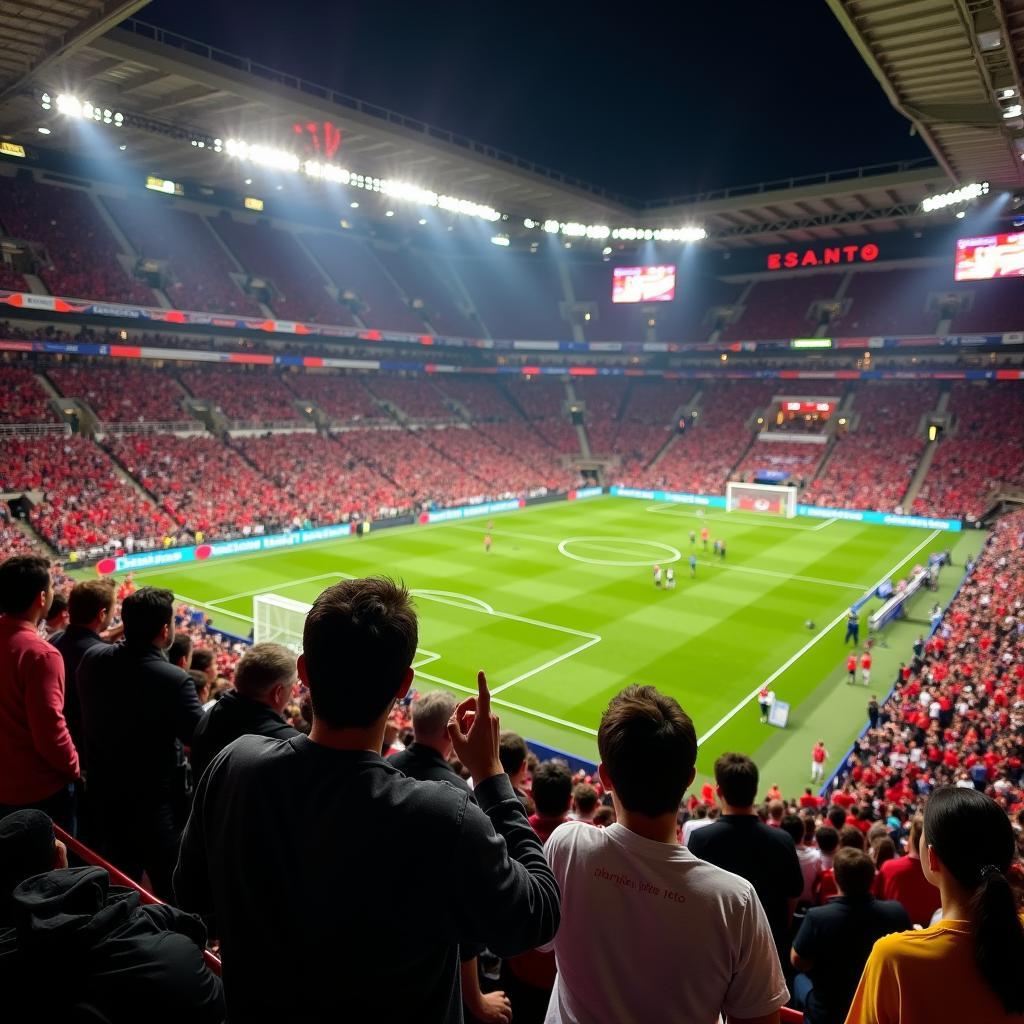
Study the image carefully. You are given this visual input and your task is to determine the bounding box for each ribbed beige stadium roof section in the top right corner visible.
[828,0,1024,188]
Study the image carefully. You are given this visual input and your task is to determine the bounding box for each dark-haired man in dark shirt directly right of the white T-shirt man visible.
[689,754,804,974]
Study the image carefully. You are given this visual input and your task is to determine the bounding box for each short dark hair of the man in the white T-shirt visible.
[597,684,697,817]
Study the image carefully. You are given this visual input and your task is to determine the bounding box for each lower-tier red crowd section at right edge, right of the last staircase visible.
[913,382,1024,518]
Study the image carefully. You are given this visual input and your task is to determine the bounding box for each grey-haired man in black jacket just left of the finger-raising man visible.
[190,643,299,779]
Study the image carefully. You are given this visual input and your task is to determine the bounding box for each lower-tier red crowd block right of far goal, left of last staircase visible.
[804,383,938,512]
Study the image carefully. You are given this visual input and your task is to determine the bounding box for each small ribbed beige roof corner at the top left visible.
[0,0,148,98]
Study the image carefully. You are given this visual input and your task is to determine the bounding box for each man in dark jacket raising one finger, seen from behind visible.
[174,579,559,1024]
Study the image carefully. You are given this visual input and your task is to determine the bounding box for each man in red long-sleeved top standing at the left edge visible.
[0,555,79,828]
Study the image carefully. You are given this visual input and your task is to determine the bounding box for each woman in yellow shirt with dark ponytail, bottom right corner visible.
[846,786,1024,1024]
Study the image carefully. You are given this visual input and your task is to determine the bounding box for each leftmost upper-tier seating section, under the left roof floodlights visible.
[0,177,157,306]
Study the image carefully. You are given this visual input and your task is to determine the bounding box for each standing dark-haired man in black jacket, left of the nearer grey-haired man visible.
[78,587,203,899]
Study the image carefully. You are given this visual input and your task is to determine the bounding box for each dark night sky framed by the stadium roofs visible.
[138,0,929,199]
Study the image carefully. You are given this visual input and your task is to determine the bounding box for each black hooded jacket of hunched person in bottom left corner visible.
[0,867,224,1024]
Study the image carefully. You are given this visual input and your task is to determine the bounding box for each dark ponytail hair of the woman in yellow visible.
[925,786,1024,1014]
